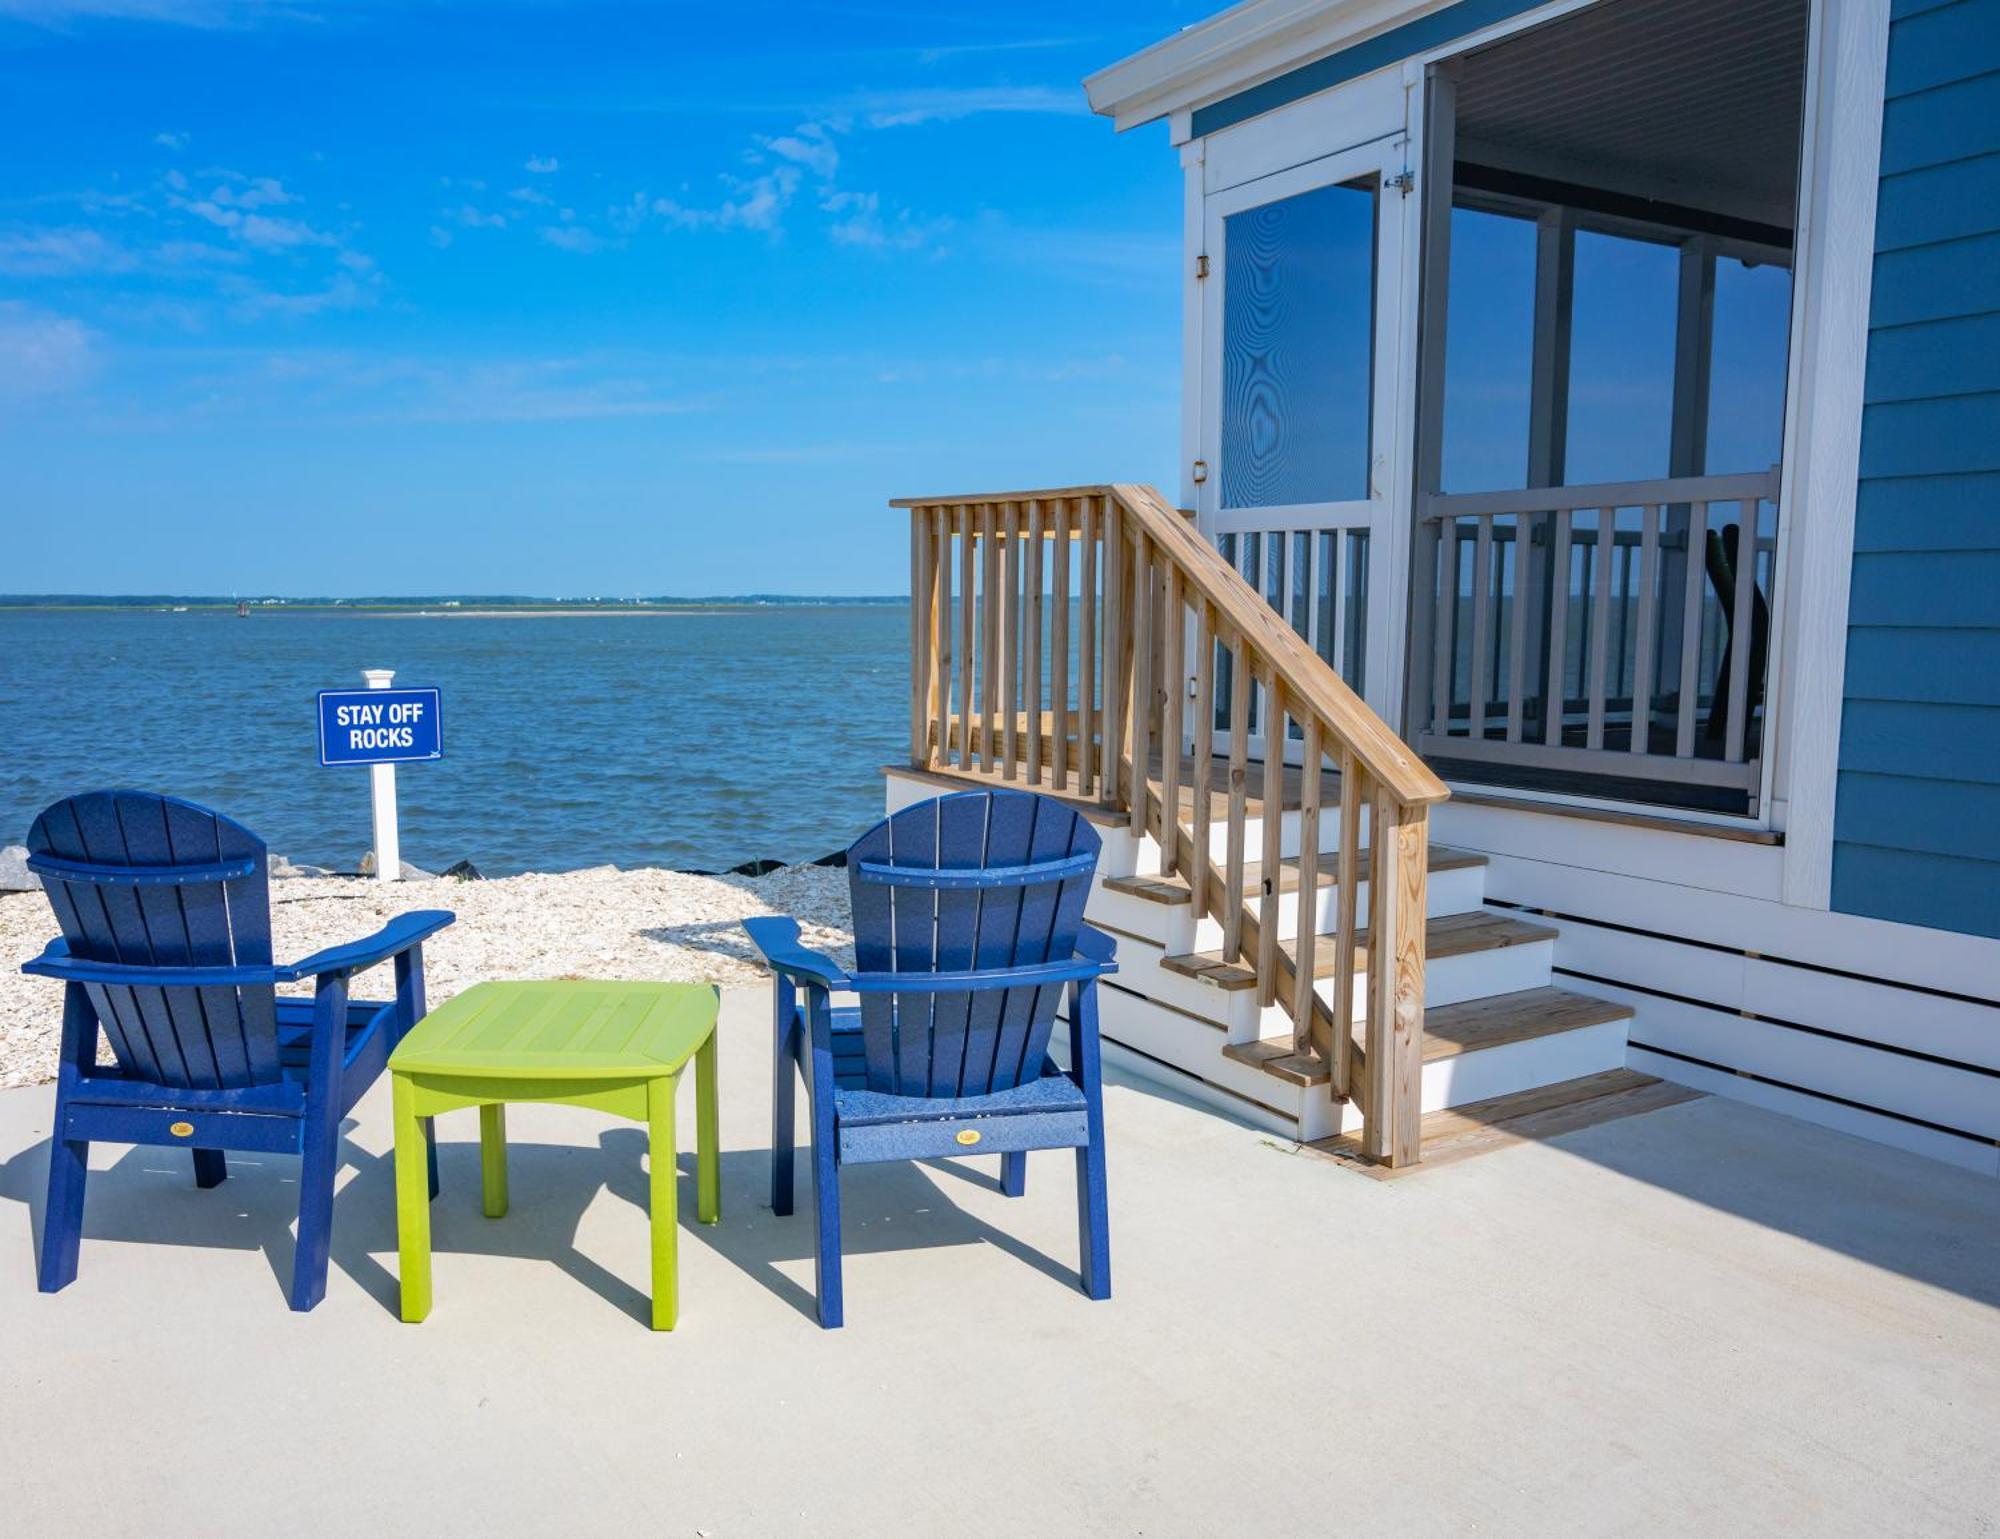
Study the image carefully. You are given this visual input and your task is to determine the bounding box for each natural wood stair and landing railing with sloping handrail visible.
[894,486,1446,1165]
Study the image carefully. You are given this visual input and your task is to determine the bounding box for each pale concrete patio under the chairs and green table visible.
[0,989,2000,1539]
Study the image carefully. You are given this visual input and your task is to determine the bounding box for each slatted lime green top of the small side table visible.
[390,981,720,1079]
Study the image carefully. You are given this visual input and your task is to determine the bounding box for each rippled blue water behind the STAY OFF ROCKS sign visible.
[0,606,910,873]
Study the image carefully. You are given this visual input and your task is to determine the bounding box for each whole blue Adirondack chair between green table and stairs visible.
[744,791,1118,1329]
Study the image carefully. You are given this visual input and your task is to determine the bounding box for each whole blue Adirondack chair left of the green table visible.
[22,791,452,1309]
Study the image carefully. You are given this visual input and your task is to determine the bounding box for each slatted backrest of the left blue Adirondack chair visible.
[28,791,280,1089]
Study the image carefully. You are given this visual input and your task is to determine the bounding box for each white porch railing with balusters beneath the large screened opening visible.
[1416,470,1778,811]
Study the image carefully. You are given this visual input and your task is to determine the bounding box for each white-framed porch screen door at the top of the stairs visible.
[1198,134,1406,740]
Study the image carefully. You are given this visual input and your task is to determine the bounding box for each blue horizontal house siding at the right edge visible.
[1834,0,2000,935]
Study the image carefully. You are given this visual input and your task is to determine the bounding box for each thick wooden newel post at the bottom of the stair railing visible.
[1364,785,1428,1165]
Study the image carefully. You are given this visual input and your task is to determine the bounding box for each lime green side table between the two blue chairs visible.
[388,983,722,1331]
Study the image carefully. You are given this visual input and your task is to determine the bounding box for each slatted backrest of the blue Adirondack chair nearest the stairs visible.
[848,791,1100,1097]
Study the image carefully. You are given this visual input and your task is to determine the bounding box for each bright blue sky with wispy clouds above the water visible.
[0,0,1214,596]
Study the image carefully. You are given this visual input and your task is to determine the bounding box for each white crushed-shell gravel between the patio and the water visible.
[0,865,854,1087]
